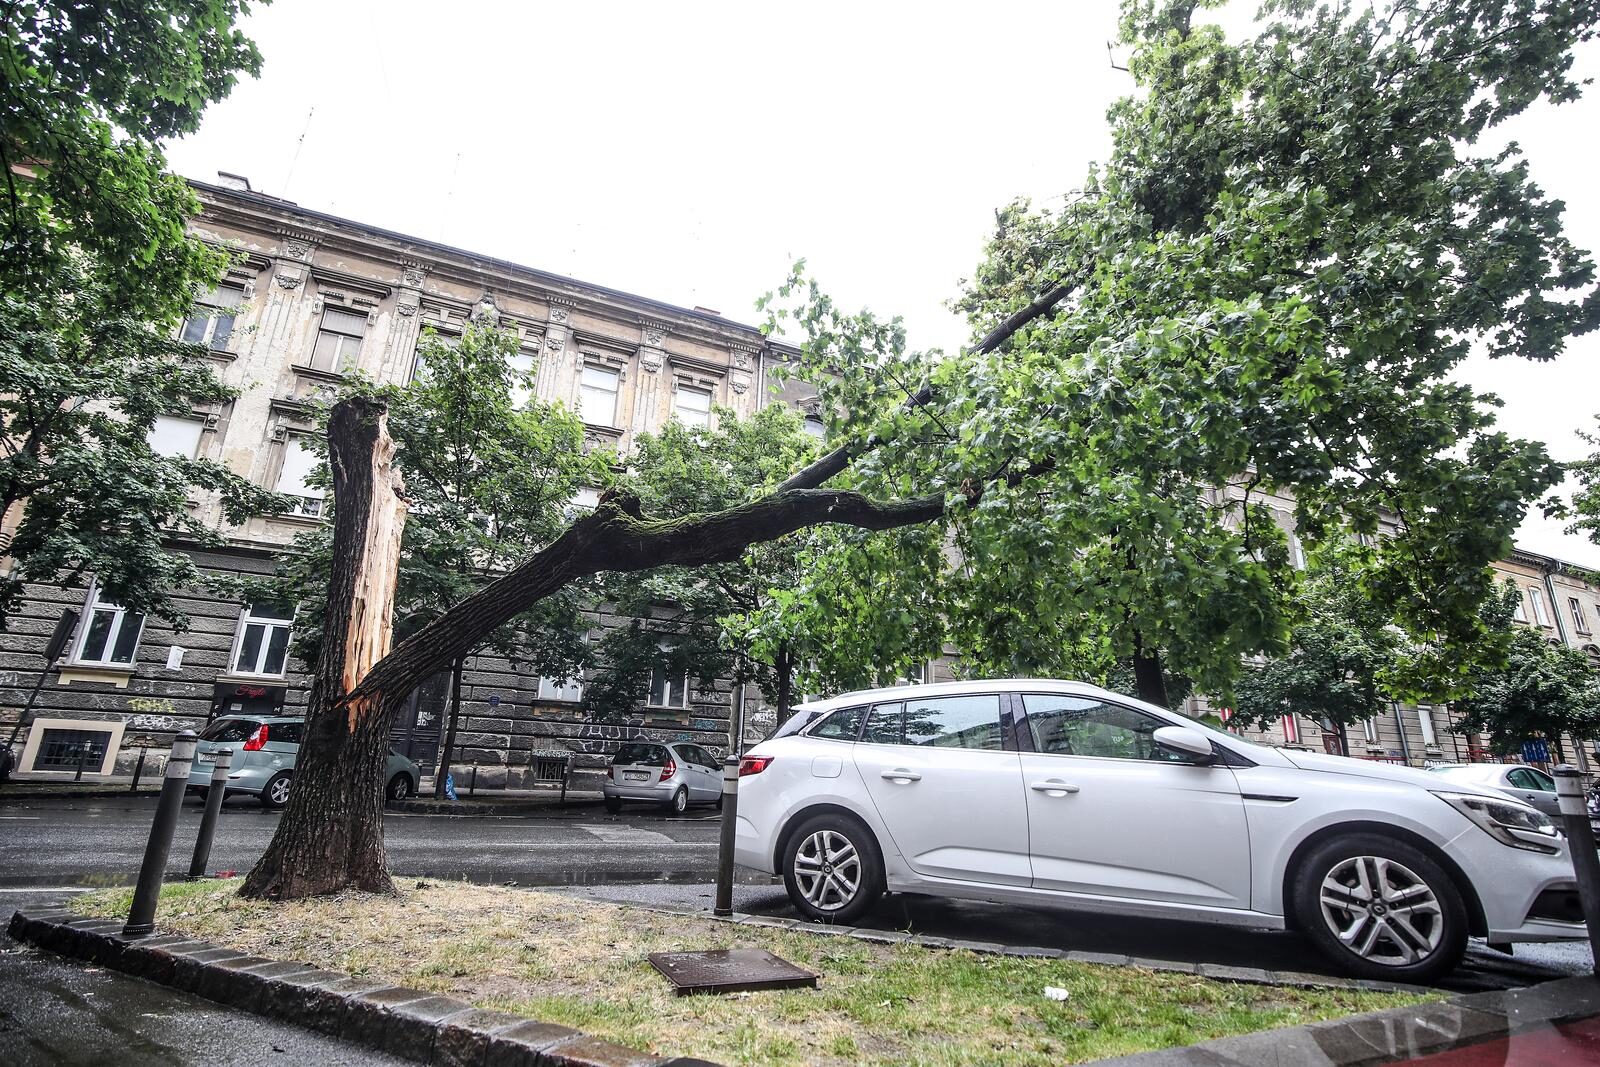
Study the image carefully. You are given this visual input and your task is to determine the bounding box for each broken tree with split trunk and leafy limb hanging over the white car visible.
[236,0,1600,896]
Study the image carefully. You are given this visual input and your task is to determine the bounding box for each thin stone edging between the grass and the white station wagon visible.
[579,893,1437,993]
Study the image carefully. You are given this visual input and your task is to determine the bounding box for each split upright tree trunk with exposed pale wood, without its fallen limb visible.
[240,397,410,899]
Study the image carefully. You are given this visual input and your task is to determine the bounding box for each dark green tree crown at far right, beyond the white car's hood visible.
[1454,582,1600,752]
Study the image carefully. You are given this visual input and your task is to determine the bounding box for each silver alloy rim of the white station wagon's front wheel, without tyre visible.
[1320,856,1445,966]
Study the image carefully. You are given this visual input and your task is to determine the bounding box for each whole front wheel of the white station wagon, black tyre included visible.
[1291,833,1467,982]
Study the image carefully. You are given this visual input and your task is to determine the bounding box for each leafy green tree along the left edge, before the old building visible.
[0,0,275,624]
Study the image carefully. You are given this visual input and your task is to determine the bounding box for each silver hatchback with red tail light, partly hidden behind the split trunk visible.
[189,715,422,808]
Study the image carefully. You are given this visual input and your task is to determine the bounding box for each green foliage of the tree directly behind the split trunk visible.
[259,325,610,677]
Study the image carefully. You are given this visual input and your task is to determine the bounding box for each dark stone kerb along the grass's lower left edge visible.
[6,912,717,1067]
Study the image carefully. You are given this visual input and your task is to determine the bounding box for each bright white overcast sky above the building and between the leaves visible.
[170,0,1600,569]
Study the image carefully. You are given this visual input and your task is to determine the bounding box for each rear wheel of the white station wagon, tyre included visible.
[782,814,883,923]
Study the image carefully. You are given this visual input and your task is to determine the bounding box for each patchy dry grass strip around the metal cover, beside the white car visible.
[78,881,1416,1067]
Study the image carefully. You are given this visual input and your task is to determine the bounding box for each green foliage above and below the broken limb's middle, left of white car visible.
[582,405,824,718]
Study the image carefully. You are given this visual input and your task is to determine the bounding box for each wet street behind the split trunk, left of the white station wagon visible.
[0,793,718,888]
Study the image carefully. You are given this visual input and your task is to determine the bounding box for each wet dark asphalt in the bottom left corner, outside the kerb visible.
[0,893,406,1067]
